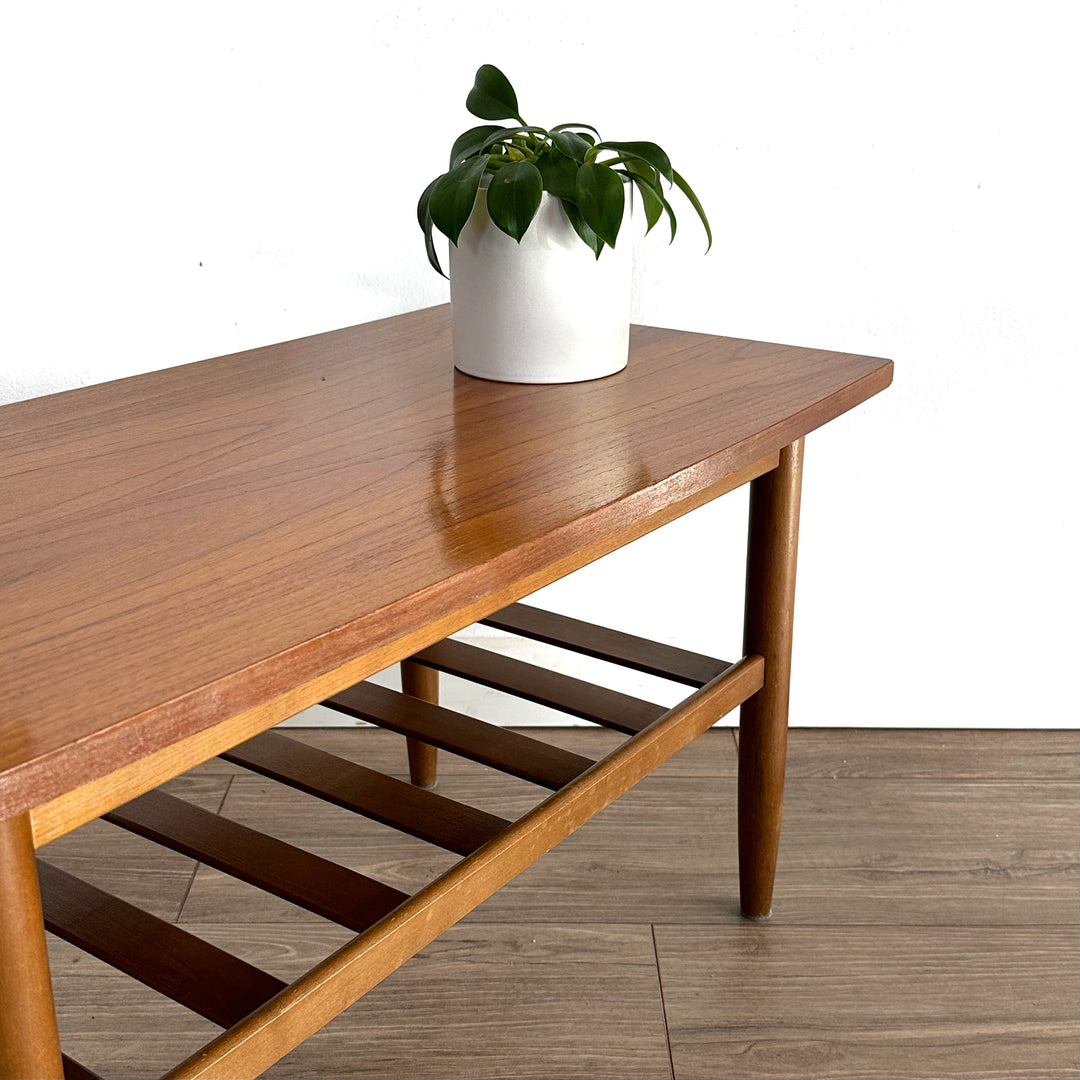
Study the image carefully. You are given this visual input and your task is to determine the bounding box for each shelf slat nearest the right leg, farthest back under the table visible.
[481,604,729,688]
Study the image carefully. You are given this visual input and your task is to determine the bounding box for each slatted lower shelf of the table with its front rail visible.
[39,604,764,1078]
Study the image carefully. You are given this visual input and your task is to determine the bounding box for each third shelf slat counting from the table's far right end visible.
[323,683,595,791]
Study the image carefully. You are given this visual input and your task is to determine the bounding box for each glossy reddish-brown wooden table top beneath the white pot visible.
[0,306,892,815]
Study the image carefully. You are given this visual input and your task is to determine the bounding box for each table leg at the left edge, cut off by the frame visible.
[0,814,64,1080]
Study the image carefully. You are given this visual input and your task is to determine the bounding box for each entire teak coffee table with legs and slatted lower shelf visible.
[0,306,892,1078]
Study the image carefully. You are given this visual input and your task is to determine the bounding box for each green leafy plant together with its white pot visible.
[417,64,713,382]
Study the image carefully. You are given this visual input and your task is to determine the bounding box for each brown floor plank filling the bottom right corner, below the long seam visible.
[656,924,1080,1080]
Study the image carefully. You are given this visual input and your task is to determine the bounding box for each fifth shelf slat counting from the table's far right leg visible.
[105,792,407,931]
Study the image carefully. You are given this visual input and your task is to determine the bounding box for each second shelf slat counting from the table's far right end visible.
[413,639,666,735]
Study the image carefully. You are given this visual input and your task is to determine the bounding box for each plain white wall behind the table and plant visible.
[0,0,1080,727]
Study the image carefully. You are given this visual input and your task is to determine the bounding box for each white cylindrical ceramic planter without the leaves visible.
[450,188,633,382]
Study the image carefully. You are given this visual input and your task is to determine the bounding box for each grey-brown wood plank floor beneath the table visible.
[43,728,1080,1080]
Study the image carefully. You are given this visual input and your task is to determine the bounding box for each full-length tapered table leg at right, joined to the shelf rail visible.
[739,438,802,919]
